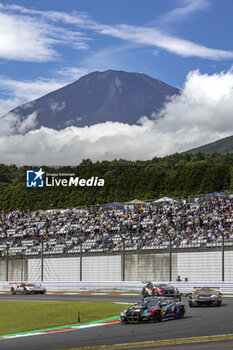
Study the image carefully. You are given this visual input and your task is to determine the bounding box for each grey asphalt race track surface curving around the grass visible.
[0,295,233,350]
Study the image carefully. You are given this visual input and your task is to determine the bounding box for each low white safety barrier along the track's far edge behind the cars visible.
[0,281,233,294]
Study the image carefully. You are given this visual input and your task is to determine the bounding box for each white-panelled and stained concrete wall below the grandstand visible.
[0,250,233,282]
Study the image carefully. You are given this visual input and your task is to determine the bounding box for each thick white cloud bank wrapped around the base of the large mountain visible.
[0,71,233,165]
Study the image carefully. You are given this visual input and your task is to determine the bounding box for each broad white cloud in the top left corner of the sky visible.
[0,4,90,62]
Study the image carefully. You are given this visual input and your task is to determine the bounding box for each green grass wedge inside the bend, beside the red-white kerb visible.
[0,301,128,335]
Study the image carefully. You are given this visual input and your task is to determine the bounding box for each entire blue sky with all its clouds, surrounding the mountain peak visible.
[0,0,233,165]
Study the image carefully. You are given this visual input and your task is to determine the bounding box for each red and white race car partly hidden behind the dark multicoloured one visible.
[142,282,181,300]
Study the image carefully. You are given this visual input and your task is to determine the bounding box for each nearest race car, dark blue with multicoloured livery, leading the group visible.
[120,297,185,323]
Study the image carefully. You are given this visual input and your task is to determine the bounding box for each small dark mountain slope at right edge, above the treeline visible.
[183,136,233,154]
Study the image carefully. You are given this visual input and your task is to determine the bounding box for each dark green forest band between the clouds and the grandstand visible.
[0,153,233,211]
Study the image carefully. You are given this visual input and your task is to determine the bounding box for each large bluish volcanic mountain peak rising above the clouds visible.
[2,70,179,130]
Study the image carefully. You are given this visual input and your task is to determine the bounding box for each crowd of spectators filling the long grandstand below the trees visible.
[0,198,233,255]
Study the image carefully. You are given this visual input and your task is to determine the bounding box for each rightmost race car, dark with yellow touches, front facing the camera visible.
[189,287,222,307]
